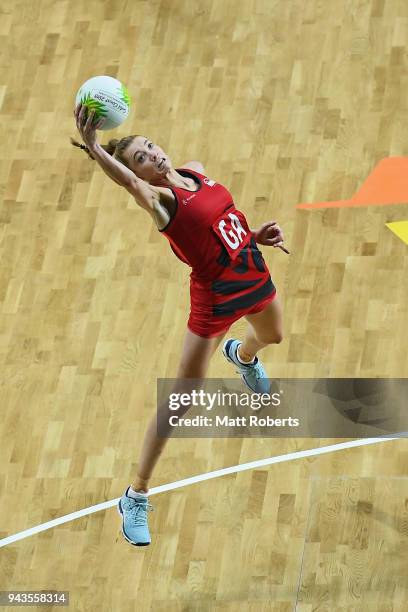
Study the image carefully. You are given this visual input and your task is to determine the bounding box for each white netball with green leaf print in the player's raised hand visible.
[75,76,131,130]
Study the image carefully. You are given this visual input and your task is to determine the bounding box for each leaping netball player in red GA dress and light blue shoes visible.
[71,105,285,546]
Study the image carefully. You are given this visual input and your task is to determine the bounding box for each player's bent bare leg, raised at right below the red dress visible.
[238,296,283,361]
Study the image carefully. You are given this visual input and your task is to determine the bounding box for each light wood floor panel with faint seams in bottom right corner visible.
[299,476,408,612]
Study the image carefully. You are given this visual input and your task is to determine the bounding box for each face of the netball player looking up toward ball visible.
[124,136,171,183]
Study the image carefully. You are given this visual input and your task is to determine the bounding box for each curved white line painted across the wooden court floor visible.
[0,432,408,548]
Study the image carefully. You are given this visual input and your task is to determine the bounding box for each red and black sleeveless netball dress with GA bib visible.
[160,168,276,338]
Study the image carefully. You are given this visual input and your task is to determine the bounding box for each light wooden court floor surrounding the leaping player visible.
[0,0,408,612]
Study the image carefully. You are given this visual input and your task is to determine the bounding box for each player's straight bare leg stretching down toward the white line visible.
[132,328,225,493]
